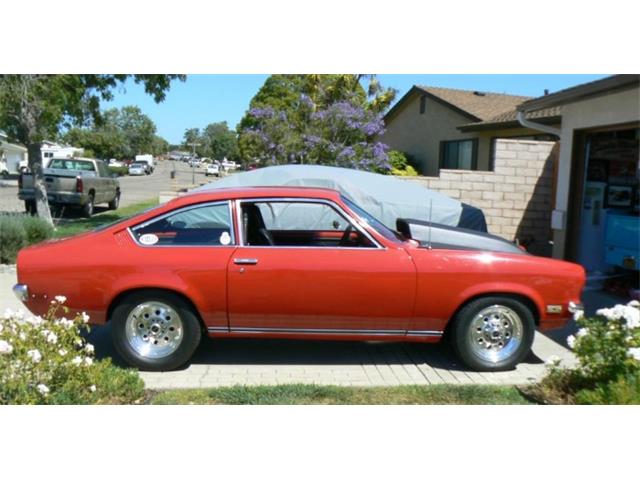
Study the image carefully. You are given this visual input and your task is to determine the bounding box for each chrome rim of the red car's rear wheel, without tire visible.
[125,301,184,359]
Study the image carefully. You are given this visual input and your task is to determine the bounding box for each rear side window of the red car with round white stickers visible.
[131,202,235,246]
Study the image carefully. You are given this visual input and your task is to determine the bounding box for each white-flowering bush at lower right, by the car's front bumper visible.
[542,300,640,404]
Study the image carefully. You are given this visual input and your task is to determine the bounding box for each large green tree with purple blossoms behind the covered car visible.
[239,75,393,172]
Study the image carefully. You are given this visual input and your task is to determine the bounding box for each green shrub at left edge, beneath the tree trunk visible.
[0,214,53,263]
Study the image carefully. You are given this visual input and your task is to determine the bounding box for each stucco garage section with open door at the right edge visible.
[517,75,640,274]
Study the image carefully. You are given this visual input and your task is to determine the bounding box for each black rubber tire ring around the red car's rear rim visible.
[111,290,202,371]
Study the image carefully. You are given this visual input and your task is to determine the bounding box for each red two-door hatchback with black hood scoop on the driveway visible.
[14,187,585,370]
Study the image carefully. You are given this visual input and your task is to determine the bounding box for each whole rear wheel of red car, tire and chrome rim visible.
[111,291,202,371]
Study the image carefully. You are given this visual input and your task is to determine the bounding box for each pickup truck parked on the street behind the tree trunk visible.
[18,157,120,217]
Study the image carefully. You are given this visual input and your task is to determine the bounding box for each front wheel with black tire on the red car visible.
[451,296,536,372]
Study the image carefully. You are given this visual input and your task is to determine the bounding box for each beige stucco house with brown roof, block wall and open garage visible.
[384,75,640,278]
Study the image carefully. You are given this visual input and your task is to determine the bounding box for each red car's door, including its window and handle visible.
[228,199,416,335]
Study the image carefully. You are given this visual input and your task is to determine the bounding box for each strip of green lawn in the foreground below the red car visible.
[150,384,531,405]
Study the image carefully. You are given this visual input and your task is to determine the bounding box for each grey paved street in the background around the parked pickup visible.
[0,161,215,212]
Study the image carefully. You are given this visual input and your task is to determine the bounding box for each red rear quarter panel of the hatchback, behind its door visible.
[18,230,235,326]
